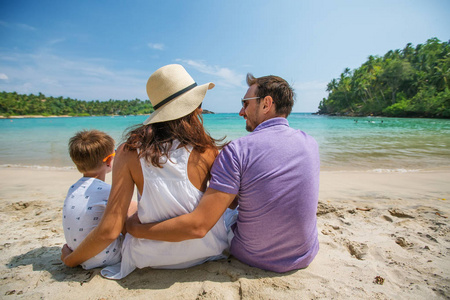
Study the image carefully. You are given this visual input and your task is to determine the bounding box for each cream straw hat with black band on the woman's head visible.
[144,65,214,125]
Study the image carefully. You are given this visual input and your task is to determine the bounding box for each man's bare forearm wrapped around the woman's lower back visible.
[126,188,236,242]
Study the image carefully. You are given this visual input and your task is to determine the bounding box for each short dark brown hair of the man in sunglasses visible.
[247,73,295,117]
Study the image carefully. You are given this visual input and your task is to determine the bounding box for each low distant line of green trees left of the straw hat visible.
[0,92,153,117]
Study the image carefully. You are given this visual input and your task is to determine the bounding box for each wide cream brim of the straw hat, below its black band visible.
[143,82,214,125]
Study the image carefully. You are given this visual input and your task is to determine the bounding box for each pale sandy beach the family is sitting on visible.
[0,167,450,299]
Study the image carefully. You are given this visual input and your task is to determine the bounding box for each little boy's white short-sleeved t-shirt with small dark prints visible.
[63,177,123,270]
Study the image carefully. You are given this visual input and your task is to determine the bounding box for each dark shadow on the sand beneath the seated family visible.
[6,246,295,289]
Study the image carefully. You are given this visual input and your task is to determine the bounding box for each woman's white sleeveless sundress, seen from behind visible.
[101,141,228,279]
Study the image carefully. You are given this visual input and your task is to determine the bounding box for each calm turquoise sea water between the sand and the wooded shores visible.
[0,113,450,172]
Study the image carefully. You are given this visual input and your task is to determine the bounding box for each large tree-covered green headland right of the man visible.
[318,38,450,118]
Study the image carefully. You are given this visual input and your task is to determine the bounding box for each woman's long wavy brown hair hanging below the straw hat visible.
[125,109,224,168]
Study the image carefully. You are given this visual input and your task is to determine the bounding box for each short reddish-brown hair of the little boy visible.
[69,130,114,173]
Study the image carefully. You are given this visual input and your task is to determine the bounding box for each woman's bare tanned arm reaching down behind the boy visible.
[61,145,137,267]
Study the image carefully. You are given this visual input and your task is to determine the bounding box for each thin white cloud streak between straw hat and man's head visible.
[176,59,245,87]
